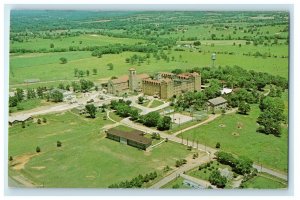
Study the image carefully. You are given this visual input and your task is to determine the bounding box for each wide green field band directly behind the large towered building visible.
[10,46,288,85]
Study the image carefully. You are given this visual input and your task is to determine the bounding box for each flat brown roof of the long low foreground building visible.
[106,128,152,145]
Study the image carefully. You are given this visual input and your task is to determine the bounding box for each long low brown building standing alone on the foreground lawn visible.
[105,128,152,150]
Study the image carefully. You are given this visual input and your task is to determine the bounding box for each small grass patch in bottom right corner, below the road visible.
[243,173,287,189]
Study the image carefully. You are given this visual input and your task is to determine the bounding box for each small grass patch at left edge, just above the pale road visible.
[9,99,54,113]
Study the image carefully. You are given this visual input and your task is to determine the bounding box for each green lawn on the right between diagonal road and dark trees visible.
[179,105,288,172]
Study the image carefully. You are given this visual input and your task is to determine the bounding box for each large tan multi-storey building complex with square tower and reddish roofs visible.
[108,68,201,99]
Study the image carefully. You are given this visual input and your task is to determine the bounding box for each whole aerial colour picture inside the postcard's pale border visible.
[5,9,290,190]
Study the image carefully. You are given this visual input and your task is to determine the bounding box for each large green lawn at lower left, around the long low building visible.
[9,112,190,187]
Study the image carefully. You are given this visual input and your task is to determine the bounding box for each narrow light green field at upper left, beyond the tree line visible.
[10,34,144,50]
